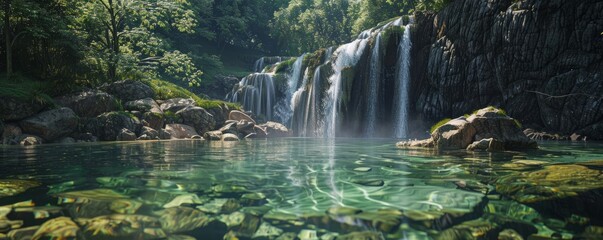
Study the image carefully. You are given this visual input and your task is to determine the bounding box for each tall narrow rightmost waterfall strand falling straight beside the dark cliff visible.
[394,18,413,138]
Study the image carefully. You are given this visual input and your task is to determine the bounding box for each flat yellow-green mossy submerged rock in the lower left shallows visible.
[56,189,142,218]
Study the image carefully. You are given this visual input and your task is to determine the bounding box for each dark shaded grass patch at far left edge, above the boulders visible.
[0,75,55,106]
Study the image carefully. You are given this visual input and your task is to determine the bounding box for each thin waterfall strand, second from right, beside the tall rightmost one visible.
[364,33,381,137]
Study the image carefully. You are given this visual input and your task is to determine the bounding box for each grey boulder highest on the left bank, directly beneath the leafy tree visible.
[101,80,155,102]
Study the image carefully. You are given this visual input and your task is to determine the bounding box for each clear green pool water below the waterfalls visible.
[0,138,603,239]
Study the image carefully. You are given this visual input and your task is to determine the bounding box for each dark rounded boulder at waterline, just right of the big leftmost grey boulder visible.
[85,112,142,141]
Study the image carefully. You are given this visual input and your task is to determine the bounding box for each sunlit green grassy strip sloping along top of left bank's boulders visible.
[143,79,241,109]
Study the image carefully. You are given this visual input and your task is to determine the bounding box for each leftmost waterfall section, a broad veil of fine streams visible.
[229,73,275,120]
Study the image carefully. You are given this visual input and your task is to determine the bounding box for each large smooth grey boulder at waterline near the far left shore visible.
[19,107,78,141]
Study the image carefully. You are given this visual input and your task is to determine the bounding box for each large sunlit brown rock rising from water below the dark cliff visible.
[397,107,538,151]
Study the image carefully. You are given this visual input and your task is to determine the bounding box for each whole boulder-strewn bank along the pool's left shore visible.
[0,81,289,145]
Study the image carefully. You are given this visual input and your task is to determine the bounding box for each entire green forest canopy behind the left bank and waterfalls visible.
[0,0,446,89]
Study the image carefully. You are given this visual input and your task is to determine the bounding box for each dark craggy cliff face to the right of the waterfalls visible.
[410,0,603,139]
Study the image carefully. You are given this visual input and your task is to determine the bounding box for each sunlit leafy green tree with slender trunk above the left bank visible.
[76,0,202,85]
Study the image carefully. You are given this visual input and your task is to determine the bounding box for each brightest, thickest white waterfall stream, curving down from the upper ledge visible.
[319,39,368,138]
